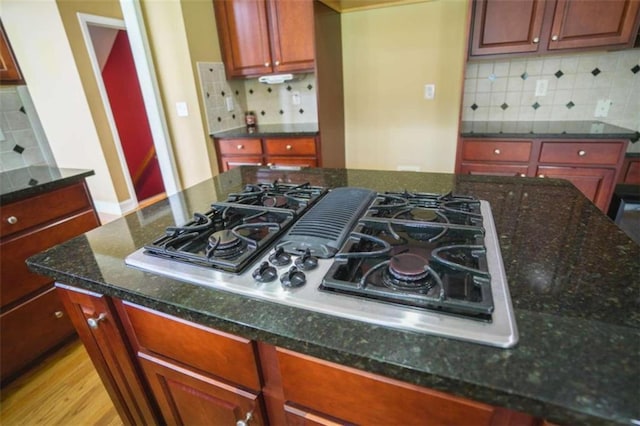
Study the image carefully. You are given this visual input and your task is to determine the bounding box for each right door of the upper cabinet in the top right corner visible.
[548,0,640,50]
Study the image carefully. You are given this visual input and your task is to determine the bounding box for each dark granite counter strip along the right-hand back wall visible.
[460,121,640,142]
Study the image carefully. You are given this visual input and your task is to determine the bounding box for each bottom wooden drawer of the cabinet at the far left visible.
[0,287,75,381]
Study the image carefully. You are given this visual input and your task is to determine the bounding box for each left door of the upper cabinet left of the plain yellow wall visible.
[213,0,273,78]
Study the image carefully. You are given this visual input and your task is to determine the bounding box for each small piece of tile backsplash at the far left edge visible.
[0,86,55,171]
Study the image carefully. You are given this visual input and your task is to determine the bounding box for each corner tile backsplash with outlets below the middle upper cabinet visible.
[198,62,318,133]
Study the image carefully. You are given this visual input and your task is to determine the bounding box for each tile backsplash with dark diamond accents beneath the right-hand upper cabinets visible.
[462,49,640,131]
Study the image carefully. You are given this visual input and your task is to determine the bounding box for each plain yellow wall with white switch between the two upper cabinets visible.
[342,0,468,172]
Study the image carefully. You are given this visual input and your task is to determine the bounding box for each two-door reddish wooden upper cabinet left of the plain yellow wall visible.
[213,0,315,78]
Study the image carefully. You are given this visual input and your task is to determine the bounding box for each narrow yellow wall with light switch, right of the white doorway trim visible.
[142,0,215,187]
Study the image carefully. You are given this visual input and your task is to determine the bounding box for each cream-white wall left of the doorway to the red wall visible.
[0,0,118,208]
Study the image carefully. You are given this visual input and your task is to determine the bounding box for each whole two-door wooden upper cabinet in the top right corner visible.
[470,0,640,57]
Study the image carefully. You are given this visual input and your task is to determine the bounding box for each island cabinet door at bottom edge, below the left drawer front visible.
[138,352,266,426]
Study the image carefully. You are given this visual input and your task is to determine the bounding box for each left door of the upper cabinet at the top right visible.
[470,0,545,56]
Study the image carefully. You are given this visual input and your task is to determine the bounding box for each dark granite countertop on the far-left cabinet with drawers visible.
[0,166,95,204]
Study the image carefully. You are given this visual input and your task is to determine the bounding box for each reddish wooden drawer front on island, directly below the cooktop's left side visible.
[124,302,261,391]
